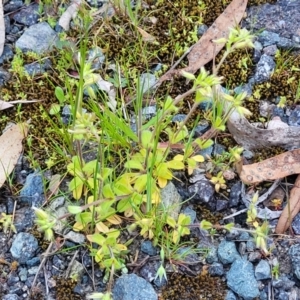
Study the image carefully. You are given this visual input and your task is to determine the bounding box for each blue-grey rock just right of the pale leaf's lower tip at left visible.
[20,171,44,207]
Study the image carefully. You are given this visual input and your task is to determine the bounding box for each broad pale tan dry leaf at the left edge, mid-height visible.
[0,123,28,187]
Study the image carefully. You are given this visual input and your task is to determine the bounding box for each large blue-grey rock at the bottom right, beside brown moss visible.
[226,258,259,300]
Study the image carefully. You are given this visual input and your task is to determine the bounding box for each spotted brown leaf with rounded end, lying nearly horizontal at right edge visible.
[239,149,300,184]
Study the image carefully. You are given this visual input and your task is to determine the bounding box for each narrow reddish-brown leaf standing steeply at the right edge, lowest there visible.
[275,175,300,234]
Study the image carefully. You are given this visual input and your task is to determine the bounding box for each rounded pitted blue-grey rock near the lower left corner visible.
[10,232,39,264]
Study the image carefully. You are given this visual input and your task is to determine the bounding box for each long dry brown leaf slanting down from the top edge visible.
[159,0,248,83]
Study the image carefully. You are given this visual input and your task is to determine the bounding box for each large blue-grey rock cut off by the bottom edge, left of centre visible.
[112,274,158,300]
